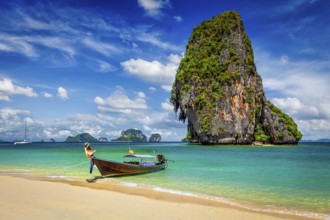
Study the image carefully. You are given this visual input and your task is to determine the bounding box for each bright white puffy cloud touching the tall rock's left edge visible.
[121,54,182,91]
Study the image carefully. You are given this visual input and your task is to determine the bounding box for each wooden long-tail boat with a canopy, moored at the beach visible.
[91,154,167,177]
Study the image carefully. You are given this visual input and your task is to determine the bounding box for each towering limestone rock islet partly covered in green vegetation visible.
[171,11,302,144]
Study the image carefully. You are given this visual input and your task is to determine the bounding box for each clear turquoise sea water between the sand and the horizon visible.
[0,143,330,219]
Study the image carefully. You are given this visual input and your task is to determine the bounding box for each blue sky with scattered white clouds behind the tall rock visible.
[0,0,330,141]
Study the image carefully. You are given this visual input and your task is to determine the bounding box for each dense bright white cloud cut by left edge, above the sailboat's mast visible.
[0,78,38,101]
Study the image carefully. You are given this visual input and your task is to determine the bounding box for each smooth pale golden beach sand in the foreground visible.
[0,175,304,220]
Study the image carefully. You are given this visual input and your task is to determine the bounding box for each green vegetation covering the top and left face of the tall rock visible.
[171,11,256,133]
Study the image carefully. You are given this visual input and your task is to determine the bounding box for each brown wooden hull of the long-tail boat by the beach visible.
[92,157,166,177]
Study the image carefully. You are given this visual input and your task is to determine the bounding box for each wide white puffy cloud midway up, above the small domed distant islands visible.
[94,89,148,114]
